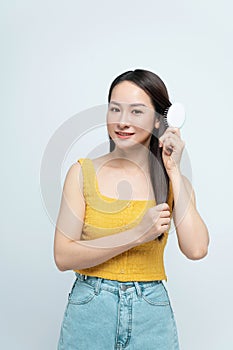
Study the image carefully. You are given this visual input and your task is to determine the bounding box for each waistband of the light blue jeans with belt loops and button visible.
[75,272,162,296]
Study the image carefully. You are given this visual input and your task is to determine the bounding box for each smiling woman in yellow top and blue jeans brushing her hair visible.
[54,70,209,350]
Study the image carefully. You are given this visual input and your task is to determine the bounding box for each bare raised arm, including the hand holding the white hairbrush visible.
[160,128,209,260]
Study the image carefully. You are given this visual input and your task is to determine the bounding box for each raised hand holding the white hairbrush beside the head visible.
[159,127,185,176]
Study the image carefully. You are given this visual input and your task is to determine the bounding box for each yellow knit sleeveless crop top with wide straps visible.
[74,158,173,282]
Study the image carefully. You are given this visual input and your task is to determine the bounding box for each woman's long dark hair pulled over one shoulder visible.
[108,69,171,204]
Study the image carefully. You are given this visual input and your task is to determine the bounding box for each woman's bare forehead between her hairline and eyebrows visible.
[111,81,153,108]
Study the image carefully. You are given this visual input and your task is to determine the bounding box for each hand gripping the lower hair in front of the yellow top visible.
[136,203,171,245]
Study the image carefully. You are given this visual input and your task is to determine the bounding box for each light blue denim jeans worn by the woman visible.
[57,273,179,350]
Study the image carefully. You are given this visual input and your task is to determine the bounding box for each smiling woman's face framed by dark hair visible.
[107,81,159,148]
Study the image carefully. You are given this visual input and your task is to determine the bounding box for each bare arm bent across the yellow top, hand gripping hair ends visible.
[54,163,170,271]
